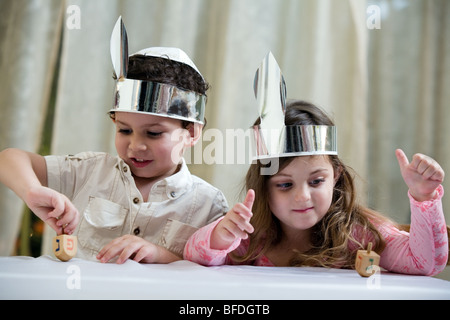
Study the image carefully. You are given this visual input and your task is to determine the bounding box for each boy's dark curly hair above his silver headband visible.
[110,54,209,128]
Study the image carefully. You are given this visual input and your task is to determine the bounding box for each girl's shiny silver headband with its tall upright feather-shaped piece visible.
[253,52,337,159]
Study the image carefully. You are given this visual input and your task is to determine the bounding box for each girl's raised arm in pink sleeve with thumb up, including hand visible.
[379,150,448,275]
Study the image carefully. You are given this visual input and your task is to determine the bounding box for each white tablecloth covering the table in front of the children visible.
[0,256,450,300]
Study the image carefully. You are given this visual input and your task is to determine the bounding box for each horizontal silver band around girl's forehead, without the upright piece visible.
[253,125,337,159]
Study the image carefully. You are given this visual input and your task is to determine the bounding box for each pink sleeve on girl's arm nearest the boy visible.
[183,217,241,266]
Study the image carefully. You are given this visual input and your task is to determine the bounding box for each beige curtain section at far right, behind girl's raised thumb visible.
[366,0,450,223]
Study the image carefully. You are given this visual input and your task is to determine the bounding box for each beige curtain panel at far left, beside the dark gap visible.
[0,0,63,255]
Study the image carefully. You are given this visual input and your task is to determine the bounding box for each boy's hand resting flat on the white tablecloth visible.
[97,235,180,264]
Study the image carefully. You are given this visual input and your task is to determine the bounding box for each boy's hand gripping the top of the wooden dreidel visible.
[24,186,80,235]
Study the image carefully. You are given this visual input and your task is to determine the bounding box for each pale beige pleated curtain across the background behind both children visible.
[0,0,450,280]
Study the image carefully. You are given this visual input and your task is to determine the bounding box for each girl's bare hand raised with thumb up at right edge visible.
[395,149,445,201]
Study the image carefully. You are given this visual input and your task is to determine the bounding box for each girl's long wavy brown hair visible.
[231,100,391,268]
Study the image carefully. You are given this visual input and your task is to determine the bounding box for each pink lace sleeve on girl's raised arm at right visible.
[378,186,448,276]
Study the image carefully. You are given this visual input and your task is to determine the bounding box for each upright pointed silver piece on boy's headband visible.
[110,16,128,81]
